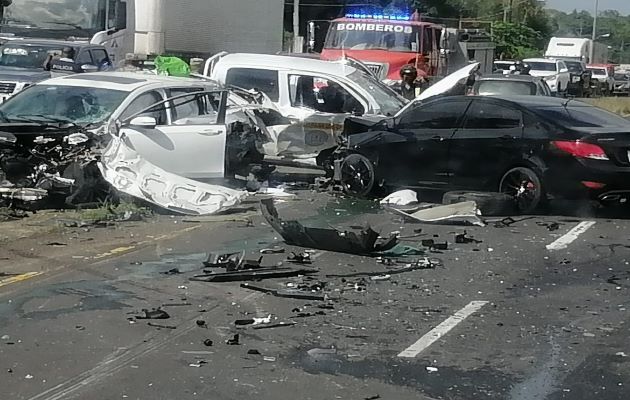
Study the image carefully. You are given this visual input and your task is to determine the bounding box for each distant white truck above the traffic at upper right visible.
[545,37,608,64]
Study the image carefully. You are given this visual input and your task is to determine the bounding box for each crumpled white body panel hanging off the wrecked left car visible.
[98,136,247,215]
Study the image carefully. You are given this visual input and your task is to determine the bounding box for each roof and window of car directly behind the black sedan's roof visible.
[473,74,551,96]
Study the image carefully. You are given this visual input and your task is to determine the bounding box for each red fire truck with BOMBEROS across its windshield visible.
[321,13,444,81]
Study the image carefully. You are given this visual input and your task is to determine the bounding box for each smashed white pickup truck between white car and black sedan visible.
[204,53,406,164]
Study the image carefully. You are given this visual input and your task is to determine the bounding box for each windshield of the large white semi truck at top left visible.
[3,0,107,35]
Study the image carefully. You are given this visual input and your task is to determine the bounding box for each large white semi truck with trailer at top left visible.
[0,0,284,64]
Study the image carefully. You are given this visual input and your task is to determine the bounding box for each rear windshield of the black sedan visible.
[534,104,630,128]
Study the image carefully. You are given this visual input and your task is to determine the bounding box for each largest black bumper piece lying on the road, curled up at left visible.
[260,199,398,255]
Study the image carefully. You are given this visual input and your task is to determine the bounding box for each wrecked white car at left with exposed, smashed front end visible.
[0,73,288,214]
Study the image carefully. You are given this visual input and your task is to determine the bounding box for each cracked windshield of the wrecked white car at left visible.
[0,85,128,125]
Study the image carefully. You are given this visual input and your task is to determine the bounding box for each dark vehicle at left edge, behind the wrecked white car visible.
[0,39,111,102]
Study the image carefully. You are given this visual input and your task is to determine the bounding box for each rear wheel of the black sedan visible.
[499,167,545,214]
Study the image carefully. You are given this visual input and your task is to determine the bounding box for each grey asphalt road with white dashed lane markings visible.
[0,192,630,400]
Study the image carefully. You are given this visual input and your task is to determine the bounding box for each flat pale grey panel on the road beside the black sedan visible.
[388,201,485,226]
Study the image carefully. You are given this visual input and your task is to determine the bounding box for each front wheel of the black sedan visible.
[341,153,376,197]
